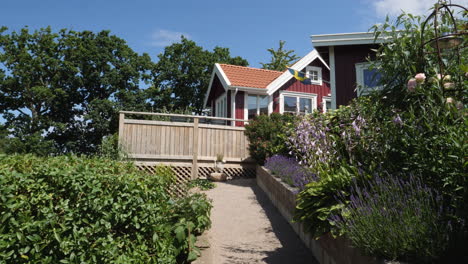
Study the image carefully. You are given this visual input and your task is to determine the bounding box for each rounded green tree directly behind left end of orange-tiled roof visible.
[152,37,248,113]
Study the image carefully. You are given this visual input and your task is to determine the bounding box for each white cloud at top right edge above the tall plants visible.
[372,0,468,17]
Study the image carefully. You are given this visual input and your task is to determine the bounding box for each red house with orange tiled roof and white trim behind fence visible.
[204,50,332,126]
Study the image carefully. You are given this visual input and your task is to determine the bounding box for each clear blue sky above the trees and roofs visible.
[0,0,460,67]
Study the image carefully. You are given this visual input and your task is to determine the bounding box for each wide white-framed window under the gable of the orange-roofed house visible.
[280,92,317,114]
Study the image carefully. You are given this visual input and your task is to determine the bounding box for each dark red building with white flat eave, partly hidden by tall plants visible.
[311,33,385,109]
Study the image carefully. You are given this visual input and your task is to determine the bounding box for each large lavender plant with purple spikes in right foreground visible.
[330,175,463,263]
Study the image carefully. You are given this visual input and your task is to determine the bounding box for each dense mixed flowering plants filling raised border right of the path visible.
[248,5,468,263]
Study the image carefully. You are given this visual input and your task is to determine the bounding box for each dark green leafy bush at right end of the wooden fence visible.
[245,113,296,165]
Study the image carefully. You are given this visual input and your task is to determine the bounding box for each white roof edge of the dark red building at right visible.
[310,32,385,48]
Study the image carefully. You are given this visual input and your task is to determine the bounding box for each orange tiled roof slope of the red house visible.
[219,64,283,88]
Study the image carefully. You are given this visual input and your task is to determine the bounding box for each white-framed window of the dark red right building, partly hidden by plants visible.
[356,62,382,96]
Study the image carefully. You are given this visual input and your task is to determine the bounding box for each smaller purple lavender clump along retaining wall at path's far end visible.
[265,155,317,190]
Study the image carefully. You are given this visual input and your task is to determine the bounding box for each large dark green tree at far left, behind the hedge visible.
[0,27,153,154]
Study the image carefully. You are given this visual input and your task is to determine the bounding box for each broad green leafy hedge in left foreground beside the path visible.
[0,155,211,263]
